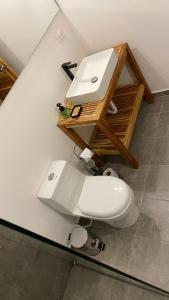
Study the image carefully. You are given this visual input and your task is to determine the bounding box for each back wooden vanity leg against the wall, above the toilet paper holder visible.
[58,125,104,166]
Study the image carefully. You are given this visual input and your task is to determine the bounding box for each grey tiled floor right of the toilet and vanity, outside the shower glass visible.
[78,95,169,292]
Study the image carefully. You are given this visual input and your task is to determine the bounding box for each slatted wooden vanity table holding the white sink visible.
[57,43,154,168]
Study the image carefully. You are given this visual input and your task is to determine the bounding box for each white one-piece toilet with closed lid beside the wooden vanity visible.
[38,160,139,228]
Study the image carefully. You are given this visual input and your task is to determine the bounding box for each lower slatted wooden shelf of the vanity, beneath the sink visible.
[89,84,144,154]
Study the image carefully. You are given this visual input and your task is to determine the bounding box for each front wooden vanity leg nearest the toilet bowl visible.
[97,120,139,169]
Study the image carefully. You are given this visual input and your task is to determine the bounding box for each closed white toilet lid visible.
[78,176,130,218]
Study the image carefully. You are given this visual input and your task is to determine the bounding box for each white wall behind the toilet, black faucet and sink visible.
[0,12,86,243]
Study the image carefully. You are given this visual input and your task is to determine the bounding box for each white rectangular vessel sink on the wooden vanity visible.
[66,48,117,104]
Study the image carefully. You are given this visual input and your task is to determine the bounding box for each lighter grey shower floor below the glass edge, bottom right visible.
[64,265,168,300]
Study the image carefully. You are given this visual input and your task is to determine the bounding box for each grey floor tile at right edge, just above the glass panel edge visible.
[127,235,169,291]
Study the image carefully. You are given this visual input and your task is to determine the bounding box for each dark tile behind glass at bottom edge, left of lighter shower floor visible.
[21,248,72,300]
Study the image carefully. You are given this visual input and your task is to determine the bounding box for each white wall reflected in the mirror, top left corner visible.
[0,0,58,71]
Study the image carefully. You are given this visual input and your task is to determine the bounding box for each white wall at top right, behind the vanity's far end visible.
[58,0,169,91]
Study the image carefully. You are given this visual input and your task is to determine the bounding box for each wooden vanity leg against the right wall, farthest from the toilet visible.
[126,44,154,103]
